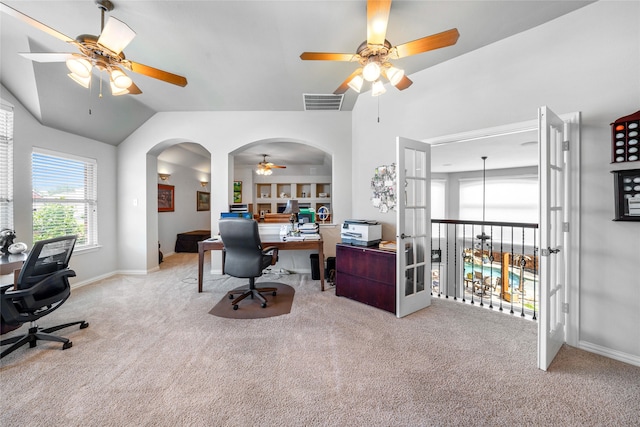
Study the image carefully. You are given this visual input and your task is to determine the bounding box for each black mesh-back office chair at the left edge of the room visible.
[0,236,89,358]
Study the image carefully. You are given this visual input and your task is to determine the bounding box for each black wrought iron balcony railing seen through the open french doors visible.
[431,219,540,320]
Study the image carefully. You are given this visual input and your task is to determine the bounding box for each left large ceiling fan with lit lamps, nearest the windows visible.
[0,0,187,96]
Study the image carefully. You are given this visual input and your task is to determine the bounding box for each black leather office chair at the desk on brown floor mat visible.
[219,218,278,310]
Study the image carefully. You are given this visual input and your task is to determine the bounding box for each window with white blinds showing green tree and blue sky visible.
[31,148,98,248]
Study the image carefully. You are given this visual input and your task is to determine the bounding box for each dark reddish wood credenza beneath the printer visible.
[335,244,396,314]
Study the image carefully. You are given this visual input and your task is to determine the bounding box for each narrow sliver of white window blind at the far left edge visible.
[0,104,13,230]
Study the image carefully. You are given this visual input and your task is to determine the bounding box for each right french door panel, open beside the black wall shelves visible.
[538,107,571,371]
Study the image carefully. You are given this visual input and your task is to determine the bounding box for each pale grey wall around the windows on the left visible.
[2,86,118,285]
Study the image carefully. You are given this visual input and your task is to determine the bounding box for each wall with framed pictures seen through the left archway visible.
[157,160,211,256]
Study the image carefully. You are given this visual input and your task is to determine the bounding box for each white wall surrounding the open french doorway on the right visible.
[352,1,640,364]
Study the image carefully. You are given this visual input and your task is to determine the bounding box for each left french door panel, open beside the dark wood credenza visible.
[396,137,431,317]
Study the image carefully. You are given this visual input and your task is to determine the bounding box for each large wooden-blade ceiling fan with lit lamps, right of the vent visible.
[300,0,460,96]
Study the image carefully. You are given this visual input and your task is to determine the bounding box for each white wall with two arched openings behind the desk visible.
[118,111,351,273]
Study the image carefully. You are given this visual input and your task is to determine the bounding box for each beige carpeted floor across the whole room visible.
[0,254,640,426]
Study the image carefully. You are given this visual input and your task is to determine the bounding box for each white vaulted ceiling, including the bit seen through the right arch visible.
[0,0,590,172]
